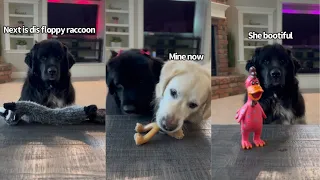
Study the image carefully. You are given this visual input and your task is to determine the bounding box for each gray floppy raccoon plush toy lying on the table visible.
[0,101,105,125]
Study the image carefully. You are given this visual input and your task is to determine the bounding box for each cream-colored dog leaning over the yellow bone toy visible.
[156,61,211,133]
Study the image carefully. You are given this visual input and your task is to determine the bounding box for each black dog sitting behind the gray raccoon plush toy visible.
[19,39,75,108]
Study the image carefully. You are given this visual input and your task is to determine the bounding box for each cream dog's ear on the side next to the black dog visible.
[156,61,185,98]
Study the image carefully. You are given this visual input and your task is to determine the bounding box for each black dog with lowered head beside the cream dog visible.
[106,49,163,115]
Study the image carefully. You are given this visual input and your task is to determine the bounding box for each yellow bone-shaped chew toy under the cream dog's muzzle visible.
[134,122,184,145]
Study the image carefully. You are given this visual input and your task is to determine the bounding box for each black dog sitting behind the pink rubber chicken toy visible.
[245,44,306,124]
